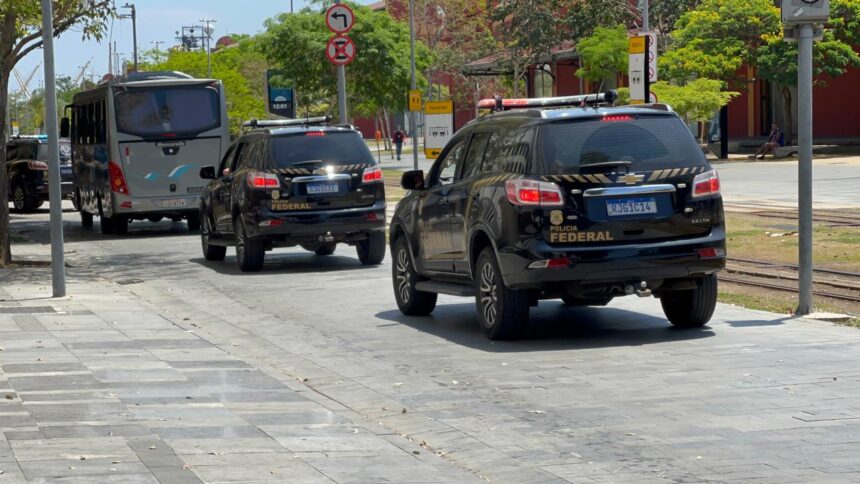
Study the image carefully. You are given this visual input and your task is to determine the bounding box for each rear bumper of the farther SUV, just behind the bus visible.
[245,200,385,242]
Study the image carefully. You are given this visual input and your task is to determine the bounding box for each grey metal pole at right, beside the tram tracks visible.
[796,24,812,315]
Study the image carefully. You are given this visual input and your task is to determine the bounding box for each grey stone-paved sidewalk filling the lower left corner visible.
[0,268,479,484]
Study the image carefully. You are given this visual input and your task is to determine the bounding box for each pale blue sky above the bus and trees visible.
[9,0,372,91]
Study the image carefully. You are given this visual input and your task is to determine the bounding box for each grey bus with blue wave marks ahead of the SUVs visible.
[61,72,230,234]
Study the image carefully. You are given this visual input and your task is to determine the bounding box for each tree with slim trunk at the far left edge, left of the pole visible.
[0,0,113,267]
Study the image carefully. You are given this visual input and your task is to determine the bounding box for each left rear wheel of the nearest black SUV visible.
[475,247,529,340]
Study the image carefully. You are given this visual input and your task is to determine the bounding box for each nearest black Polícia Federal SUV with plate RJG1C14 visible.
[390,92,725,339]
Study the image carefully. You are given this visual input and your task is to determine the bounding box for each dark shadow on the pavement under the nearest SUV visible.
[376,301,714,353]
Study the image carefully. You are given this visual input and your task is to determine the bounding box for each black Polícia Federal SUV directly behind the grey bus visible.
[200,118,385,271]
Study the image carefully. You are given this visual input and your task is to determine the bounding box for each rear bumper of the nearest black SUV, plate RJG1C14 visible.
[499,226,726,288]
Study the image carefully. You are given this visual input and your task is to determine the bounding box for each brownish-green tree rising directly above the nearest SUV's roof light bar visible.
[491,0,567,97]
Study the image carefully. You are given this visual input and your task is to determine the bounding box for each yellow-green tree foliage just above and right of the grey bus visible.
[142,38,268,133]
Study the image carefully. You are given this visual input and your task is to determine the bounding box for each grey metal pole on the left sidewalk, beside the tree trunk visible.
[42,0,66,297]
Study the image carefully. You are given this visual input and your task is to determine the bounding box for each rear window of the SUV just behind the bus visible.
[271,131,376,168]
